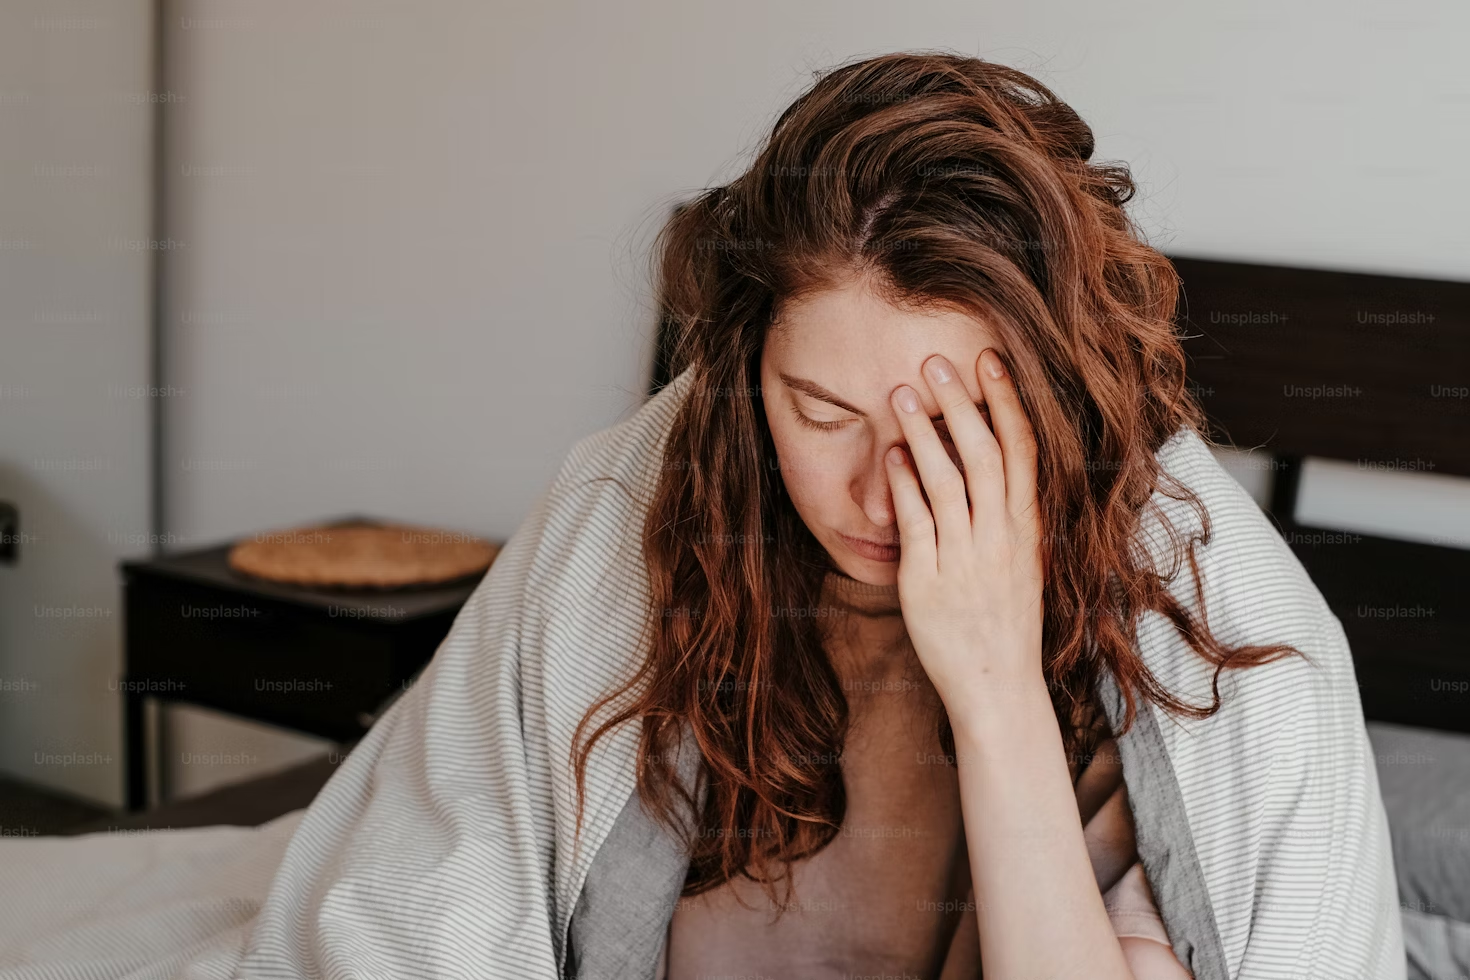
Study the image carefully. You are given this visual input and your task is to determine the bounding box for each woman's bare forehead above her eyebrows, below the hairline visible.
[766,282,1005,404]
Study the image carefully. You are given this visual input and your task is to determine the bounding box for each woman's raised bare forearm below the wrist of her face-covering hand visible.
[950,676,1133,980]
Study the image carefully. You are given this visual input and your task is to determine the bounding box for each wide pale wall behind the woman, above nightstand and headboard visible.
[155,0,1470,799]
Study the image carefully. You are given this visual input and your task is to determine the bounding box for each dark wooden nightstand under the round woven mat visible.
[119,517,484,810]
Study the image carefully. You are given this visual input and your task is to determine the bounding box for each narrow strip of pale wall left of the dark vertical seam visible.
[0,0,153,804]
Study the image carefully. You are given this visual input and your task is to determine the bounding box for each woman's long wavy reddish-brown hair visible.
[573,53,1301,899]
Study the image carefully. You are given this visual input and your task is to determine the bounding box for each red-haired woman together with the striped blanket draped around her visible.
[0,54,1405,980]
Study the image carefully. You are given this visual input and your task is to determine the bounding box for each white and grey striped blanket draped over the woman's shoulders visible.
[0,376,1405,980]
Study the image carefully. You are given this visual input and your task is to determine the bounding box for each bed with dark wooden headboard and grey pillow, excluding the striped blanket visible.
[85,257,1470,980]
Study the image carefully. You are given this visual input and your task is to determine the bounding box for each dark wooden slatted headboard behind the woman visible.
[651,256,1470,732]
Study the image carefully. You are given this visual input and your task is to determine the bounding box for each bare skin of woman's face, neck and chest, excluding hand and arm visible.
[667,284,1004,980]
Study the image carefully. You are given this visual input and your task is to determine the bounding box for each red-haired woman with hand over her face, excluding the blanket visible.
[561,54,1399,980]
